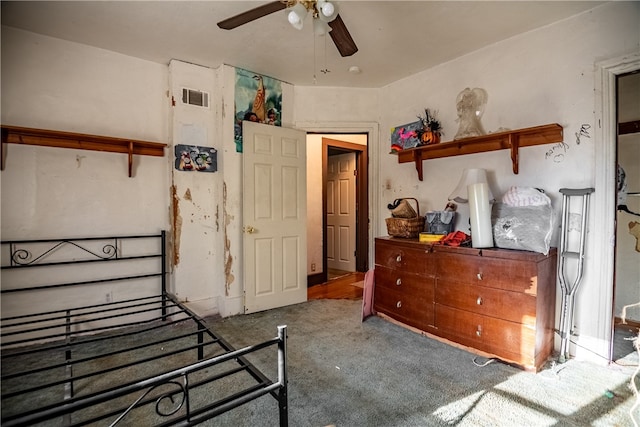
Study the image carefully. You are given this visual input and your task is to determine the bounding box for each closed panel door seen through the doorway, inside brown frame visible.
[327,153,356,271]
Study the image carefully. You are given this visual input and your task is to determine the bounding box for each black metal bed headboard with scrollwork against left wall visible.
[0,230,167,341]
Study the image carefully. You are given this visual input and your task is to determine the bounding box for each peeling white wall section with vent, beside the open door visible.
[167,60,224,315]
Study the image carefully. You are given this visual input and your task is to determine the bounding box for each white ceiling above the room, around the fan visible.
[1,0,602,87]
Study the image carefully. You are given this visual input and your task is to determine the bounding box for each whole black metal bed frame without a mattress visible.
[0,231,288,427]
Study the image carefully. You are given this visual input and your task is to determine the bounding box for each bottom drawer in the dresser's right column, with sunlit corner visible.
[435,304,536,366]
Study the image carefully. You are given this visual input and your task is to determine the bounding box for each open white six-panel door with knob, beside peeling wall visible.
[242,122,307,313]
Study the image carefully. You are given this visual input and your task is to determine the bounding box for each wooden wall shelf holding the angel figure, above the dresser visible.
[398,123,564,181]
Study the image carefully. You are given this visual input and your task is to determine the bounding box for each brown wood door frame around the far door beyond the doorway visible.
[322,138,369,282]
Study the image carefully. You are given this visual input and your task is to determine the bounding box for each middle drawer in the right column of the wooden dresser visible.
[435,278,536,326]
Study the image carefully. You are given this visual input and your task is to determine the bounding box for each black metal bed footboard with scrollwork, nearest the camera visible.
[2,326,289,427]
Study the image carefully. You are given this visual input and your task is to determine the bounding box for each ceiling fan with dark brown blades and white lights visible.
[218,0,358,56]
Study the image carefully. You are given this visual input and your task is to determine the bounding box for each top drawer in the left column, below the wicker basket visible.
[375,240,436,275]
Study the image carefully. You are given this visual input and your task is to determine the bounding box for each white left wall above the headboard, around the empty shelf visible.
[1,27,169,239]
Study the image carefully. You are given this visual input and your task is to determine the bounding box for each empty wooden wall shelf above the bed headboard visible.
[0,125,167,177]
